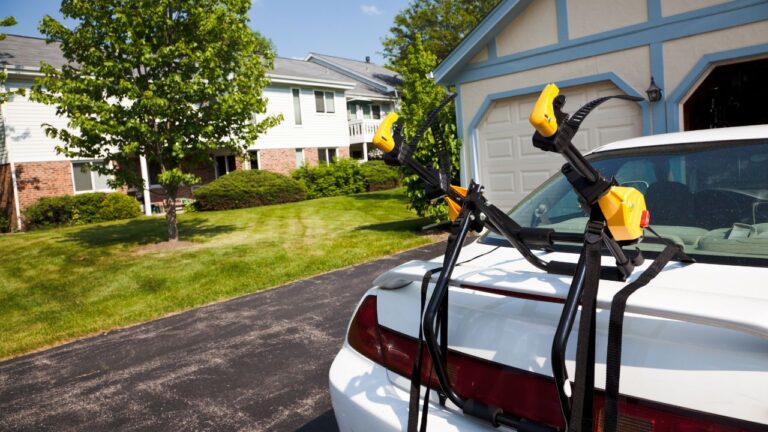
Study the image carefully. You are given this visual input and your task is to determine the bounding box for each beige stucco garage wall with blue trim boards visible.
[435,0,768,187]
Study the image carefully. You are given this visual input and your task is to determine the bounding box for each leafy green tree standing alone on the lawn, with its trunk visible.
[33,0,280,241]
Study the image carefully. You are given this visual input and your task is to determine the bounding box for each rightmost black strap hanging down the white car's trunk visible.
[603,242,685,432]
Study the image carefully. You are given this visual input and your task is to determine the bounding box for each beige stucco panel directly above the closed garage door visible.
[461,46,651,135]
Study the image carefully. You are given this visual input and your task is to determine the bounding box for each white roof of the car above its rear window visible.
[592,125,768,153]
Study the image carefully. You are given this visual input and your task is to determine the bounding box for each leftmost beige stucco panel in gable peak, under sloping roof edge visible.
[496,0,557,56]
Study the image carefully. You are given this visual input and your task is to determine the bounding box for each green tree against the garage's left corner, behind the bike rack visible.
[383,0,498,219]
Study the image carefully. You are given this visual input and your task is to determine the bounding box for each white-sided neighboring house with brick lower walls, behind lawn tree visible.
[0,35,397,228]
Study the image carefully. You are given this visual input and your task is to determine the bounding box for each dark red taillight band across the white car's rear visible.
[347,296,766,432]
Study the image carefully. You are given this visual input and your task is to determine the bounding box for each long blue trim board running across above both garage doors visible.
[444,0,768,85]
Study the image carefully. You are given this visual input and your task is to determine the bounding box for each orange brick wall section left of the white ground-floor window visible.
[16,161,75,211]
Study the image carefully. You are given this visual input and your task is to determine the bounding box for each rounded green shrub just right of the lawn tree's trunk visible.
[193,170,306,210]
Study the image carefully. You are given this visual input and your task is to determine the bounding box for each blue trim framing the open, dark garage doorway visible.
[665,44,768,132]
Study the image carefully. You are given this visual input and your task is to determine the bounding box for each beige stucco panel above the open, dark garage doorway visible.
[664,21,768,100]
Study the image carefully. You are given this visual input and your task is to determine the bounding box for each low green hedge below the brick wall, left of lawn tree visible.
[25,192,141,228]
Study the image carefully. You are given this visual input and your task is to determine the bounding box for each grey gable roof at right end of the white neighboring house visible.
[306,53,402,97]
